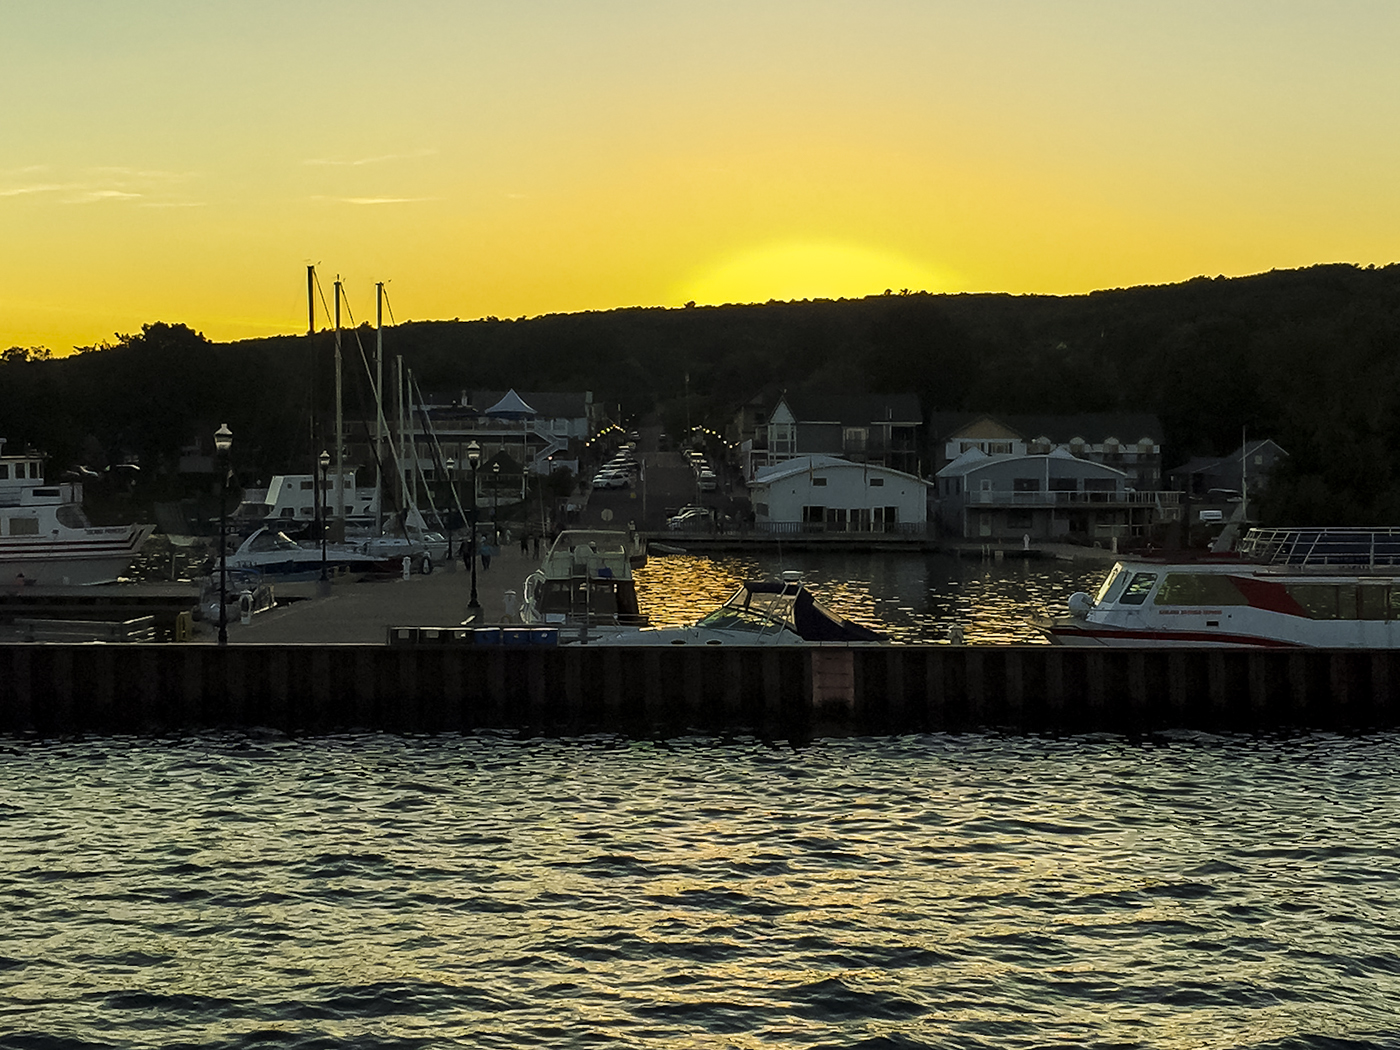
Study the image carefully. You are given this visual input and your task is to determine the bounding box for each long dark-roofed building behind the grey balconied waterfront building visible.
[928,412,1163,491]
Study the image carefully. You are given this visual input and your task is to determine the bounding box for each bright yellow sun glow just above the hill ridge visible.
[675,241,960,305]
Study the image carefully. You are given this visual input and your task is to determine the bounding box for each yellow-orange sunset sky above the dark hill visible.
[0,0,1400,353]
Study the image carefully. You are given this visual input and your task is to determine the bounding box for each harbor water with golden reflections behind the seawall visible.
[636,552,1112,645]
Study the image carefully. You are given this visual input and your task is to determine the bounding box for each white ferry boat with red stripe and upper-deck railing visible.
[1033,528,1400,648]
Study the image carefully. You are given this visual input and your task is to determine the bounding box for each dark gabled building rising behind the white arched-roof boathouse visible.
[739,392,924,480]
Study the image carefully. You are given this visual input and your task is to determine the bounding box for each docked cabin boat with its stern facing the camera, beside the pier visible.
[521,529,647,629]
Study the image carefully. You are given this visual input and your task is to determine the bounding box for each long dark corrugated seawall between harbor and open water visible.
[0,644,1400,739]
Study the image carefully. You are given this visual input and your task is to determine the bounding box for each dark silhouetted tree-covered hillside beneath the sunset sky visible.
[0,265,1400,524]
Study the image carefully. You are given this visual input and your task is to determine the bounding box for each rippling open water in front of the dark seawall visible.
[0,735,1400,1049]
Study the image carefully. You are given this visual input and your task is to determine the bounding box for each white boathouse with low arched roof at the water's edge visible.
[749,455,928,532]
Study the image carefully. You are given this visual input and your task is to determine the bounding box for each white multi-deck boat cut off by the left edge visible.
[0,438,155,587]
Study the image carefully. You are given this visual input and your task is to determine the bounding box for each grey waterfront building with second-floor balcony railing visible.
[935,447,1180,542]
